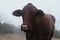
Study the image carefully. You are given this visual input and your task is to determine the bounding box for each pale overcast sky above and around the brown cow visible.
[0,0,60,30]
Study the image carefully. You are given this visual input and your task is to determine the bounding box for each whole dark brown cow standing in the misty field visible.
[13,3,55,40]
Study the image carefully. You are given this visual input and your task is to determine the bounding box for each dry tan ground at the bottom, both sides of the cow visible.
[0,34,60,40]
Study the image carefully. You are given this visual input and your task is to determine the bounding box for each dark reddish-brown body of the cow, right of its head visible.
[33,14,54,40]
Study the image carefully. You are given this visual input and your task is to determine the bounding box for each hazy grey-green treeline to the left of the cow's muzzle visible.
[0,23,20,34]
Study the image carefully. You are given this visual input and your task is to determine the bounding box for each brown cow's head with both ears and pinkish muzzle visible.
[13,3,44,31]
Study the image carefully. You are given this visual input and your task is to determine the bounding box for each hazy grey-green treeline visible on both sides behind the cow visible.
[0,23,60,38]
